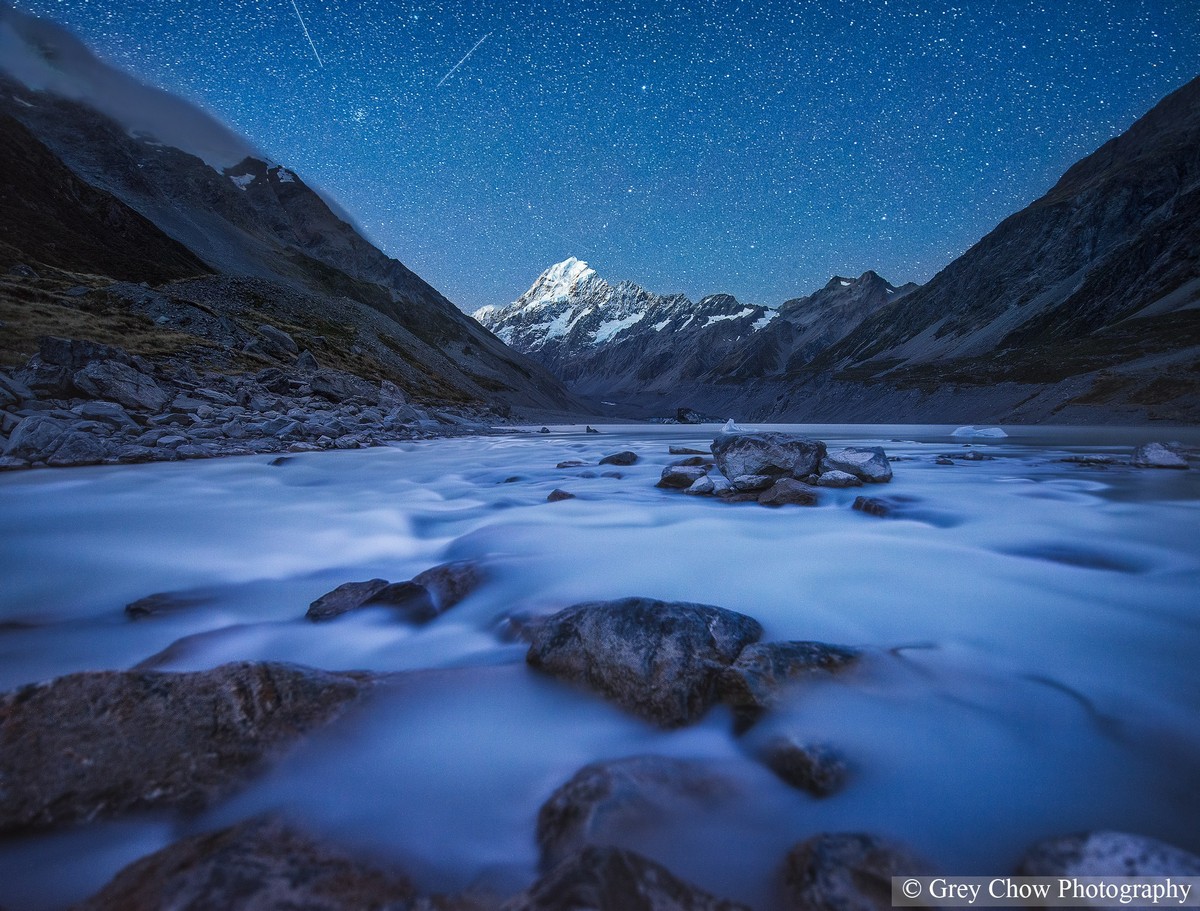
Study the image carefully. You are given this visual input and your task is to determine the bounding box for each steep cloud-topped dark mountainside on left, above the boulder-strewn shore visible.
[0,8,574,410]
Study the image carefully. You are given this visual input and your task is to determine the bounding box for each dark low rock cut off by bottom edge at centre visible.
[500,847,749,911]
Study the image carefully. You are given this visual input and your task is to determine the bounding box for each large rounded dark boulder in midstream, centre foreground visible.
[526,598,762,727]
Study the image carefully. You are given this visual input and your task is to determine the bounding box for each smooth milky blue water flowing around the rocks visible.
[0,425,1200,909]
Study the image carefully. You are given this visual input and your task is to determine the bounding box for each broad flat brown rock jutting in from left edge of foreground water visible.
[0,663,370,835]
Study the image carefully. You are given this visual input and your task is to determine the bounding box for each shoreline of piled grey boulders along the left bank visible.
[0,338,499,471]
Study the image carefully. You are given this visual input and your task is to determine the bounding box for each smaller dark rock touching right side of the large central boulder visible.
[720,641,862,729]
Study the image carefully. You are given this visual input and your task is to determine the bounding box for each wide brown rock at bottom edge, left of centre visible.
[74,817,416,911]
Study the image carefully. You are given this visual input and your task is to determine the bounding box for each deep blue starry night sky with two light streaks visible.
[14,0,1200,311]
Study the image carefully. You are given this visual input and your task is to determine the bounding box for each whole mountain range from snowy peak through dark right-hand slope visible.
[475,73,1200,422]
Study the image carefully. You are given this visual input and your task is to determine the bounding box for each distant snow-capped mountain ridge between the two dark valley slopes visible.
[474,257,911,398]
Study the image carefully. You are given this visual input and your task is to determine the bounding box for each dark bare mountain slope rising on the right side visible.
[792,78,1200,420]
